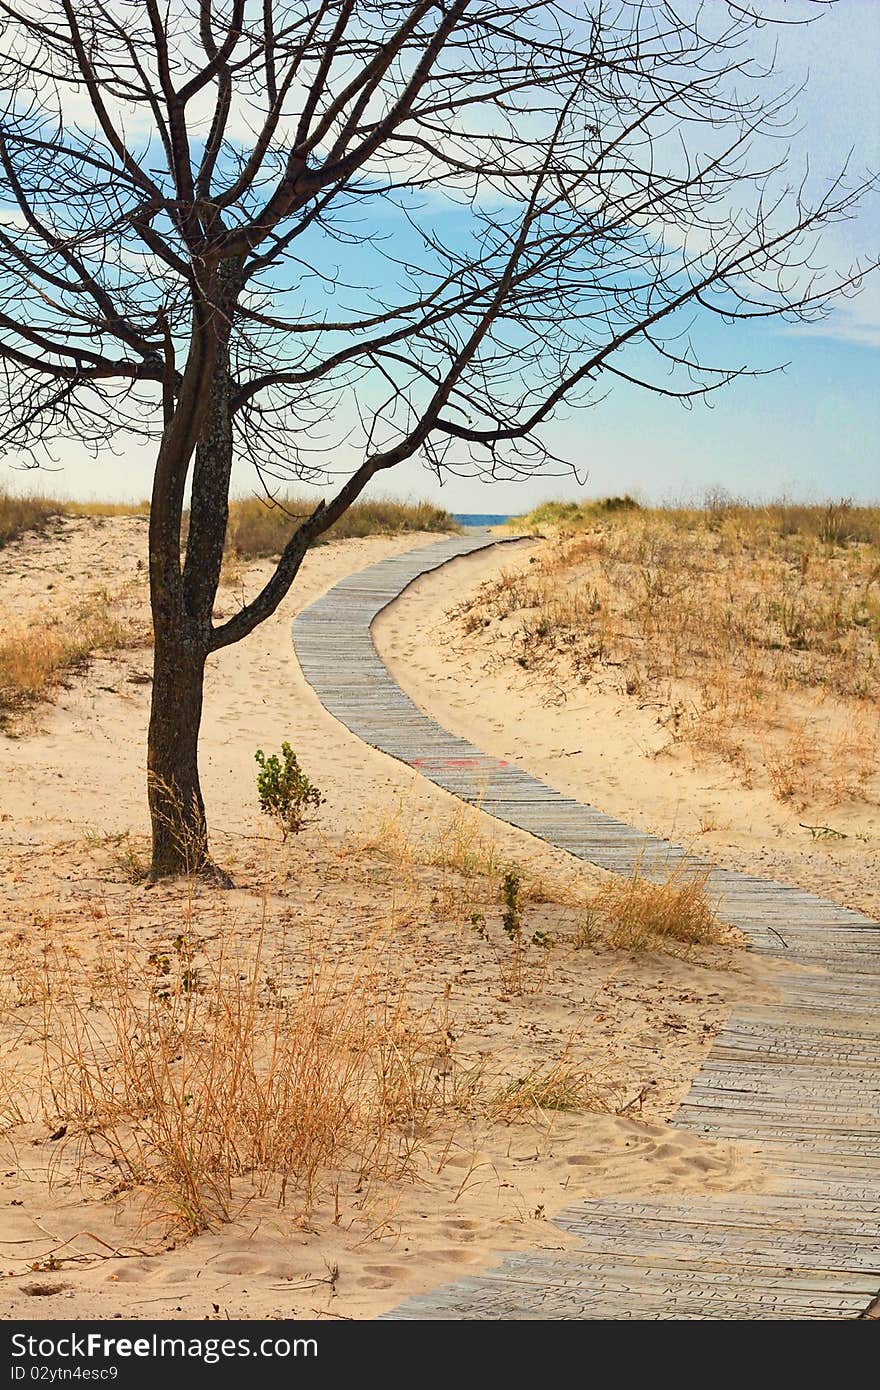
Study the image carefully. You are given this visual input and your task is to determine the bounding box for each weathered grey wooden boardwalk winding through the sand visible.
[293,532,880,1321]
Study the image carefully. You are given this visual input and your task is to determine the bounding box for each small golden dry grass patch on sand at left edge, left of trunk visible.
[0,594,149,720]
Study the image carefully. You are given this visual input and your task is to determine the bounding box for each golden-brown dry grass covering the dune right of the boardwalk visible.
[452,498,880,805]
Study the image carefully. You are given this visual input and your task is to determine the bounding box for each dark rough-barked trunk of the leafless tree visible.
[147,261,241,878]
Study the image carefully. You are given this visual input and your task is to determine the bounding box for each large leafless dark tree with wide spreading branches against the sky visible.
[0,0,870,876]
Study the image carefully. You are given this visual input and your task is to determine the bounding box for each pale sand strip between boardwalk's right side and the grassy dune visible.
[374,541,880,915]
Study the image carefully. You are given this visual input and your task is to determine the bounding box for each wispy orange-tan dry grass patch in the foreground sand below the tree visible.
[0,884,606,1233]
